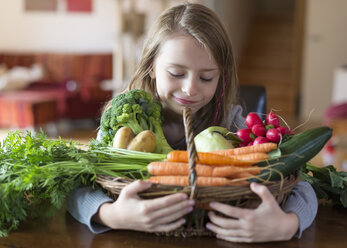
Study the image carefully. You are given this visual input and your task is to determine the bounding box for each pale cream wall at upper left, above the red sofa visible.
[0,0,116,52]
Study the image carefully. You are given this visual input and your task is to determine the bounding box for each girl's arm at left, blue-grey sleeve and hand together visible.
[67,180,194,234]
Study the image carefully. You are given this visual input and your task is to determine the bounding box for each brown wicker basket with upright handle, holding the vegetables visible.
[96,109,299,237]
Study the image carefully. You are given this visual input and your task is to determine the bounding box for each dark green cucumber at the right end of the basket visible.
[249,126,332,182]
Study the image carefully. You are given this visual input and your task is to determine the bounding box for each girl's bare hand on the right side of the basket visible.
[206,183,299,242]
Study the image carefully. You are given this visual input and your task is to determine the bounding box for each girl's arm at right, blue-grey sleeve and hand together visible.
[207,182,318,242]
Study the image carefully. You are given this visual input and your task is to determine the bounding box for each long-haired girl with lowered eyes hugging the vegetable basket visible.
[68,3,317,242]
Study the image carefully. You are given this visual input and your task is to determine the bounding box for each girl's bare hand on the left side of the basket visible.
[94,180,194,232]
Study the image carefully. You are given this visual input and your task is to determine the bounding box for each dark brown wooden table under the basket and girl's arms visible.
[0,205,347,248]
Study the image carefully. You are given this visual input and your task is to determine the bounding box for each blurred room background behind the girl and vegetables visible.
[0,0,347,167]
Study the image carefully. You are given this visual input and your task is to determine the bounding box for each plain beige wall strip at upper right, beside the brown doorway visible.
[301,0,347,122]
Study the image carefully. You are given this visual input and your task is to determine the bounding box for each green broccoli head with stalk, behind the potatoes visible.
[100,90,172,153]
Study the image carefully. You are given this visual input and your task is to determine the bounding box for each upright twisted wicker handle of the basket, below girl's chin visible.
[183,108,198,199]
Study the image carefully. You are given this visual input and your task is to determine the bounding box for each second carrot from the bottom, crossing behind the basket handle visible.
[147,162,260,177]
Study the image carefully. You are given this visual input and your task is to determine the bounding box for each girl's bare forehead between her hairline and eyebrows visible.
[157,32,217,67]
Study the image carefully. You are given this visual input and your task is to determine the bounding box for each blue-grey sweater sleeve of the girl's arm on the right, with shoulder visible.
[227,105,318,238]
